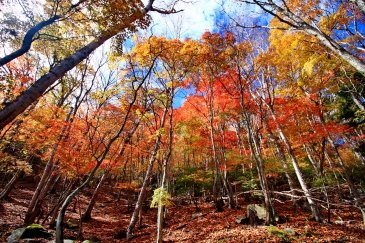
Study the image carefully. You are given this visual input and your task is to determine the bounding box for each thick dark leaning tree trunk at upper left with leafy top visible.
[0,0,181,129]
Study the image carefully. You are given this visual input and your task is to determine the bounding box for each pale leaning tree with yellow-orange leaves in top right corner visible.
[237,0,365,75]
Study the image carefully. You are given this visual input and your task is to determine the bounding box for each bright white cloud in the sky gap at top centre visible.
[144,0,220,39]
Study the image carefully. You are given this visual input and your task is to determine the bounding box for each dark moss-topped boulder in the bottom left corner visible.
[8,224,53,243]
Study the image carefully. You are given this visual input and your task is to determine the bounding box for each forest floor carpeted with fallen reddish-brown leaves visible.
[0,179,365,242]
